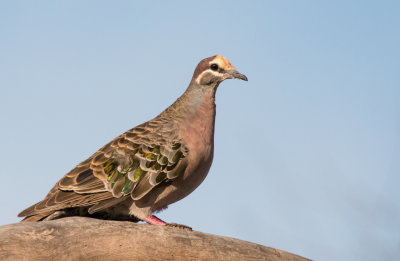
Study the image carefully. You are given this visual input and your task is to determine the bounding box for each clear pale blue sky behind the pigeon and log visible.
[0,1,400,260]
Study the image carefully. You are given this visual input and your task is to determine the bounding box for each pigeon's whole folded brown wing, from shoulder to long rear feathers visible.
[19,121,188,216]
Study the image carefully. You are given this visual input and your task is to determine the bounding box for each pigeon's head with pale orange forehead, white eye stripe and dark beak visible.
[192,55,247,86]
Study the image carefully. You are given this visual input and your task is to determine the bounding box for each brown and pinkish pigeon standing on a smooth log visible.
[18,55,248,226]
